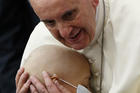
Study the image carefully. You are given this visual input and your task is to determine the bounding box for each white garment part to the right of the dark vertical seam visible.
[102,0,140,93]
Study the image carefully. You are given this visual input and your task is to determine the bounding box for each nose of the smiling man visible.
[59,26,72,38]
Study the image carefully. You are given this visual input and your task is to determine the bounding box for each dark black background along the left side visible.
[0,0,39,93]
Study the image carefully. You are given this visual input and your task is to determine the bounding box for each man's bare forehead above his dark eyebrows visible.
[31,0,82,17]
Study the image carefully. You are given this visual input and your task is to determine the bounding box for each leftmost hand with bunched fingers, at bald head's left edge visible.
[16,68,31,93]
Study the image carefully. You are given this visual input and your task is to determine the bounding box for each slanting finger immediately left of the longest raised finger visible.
[30,76,48,93]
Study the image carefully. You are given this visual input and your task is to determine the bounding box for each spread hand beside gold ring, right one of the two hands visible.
[30,72,71,93]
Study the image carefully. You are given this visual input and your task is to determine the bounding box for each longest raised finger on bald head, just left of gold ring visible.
[42,71,60,93]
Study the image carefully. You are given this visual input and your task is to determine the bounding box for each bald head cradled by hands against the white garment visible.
[23,45,90,93]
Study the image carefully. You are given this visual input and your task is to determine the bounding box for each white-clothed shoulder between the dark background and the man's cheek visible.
[21,22,63,66]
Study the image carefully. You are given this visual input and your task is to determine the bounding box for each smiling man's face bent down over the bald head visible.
[31,0,96,50]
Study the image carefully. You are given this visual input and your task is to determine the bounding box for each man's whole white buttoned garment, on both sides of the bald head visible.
[22,0,140,93]
